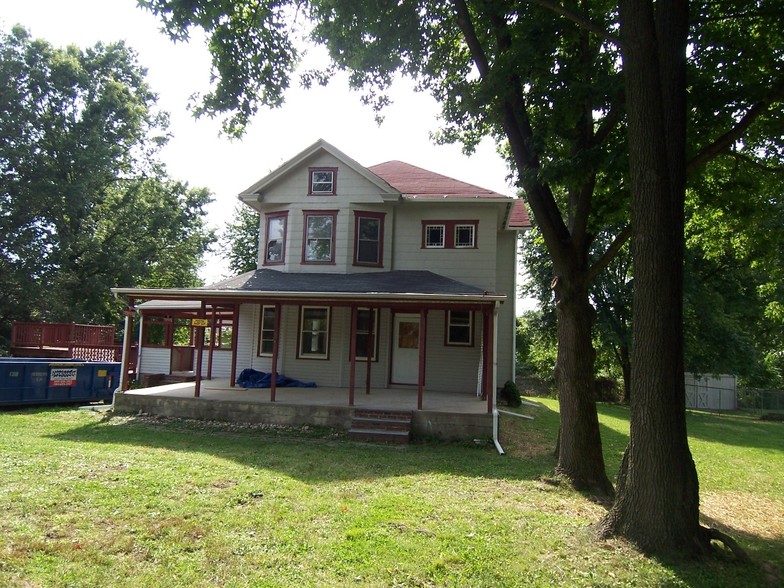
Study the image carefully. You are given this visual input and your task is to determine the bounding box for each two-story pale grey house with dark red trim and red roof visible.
[113,140,529,424]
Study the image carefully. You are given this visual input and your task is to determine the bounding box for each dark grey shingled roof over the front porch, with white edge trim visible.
[112,269,506,303]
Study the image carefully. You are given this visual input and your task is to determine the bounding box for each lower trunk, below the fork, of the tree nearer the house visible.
[555,276,613,496]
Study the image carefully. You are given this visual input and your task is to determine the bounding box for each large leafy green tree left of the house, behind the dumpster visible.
[0,27,213,350]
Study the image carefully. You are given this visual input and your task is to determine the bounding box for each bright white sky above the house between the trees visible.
[0,0,515,283]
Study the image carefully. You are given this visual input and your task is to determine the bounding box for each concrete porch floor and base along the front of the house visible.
[114,379,493,439]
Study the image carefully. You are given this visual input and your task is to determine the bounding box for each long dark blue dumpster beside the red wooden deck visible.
[0,357,121,406]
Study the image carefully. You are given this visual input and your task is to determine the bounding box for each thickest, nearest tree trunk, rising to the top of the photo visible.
[600,0,709,553]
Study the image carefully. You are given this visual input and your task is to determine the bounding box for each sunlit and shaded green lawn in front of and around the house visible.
[0,400,784,587]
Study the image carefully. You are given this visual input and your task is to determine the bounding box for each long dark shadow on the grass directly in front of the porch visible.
[44,406,552,483]
